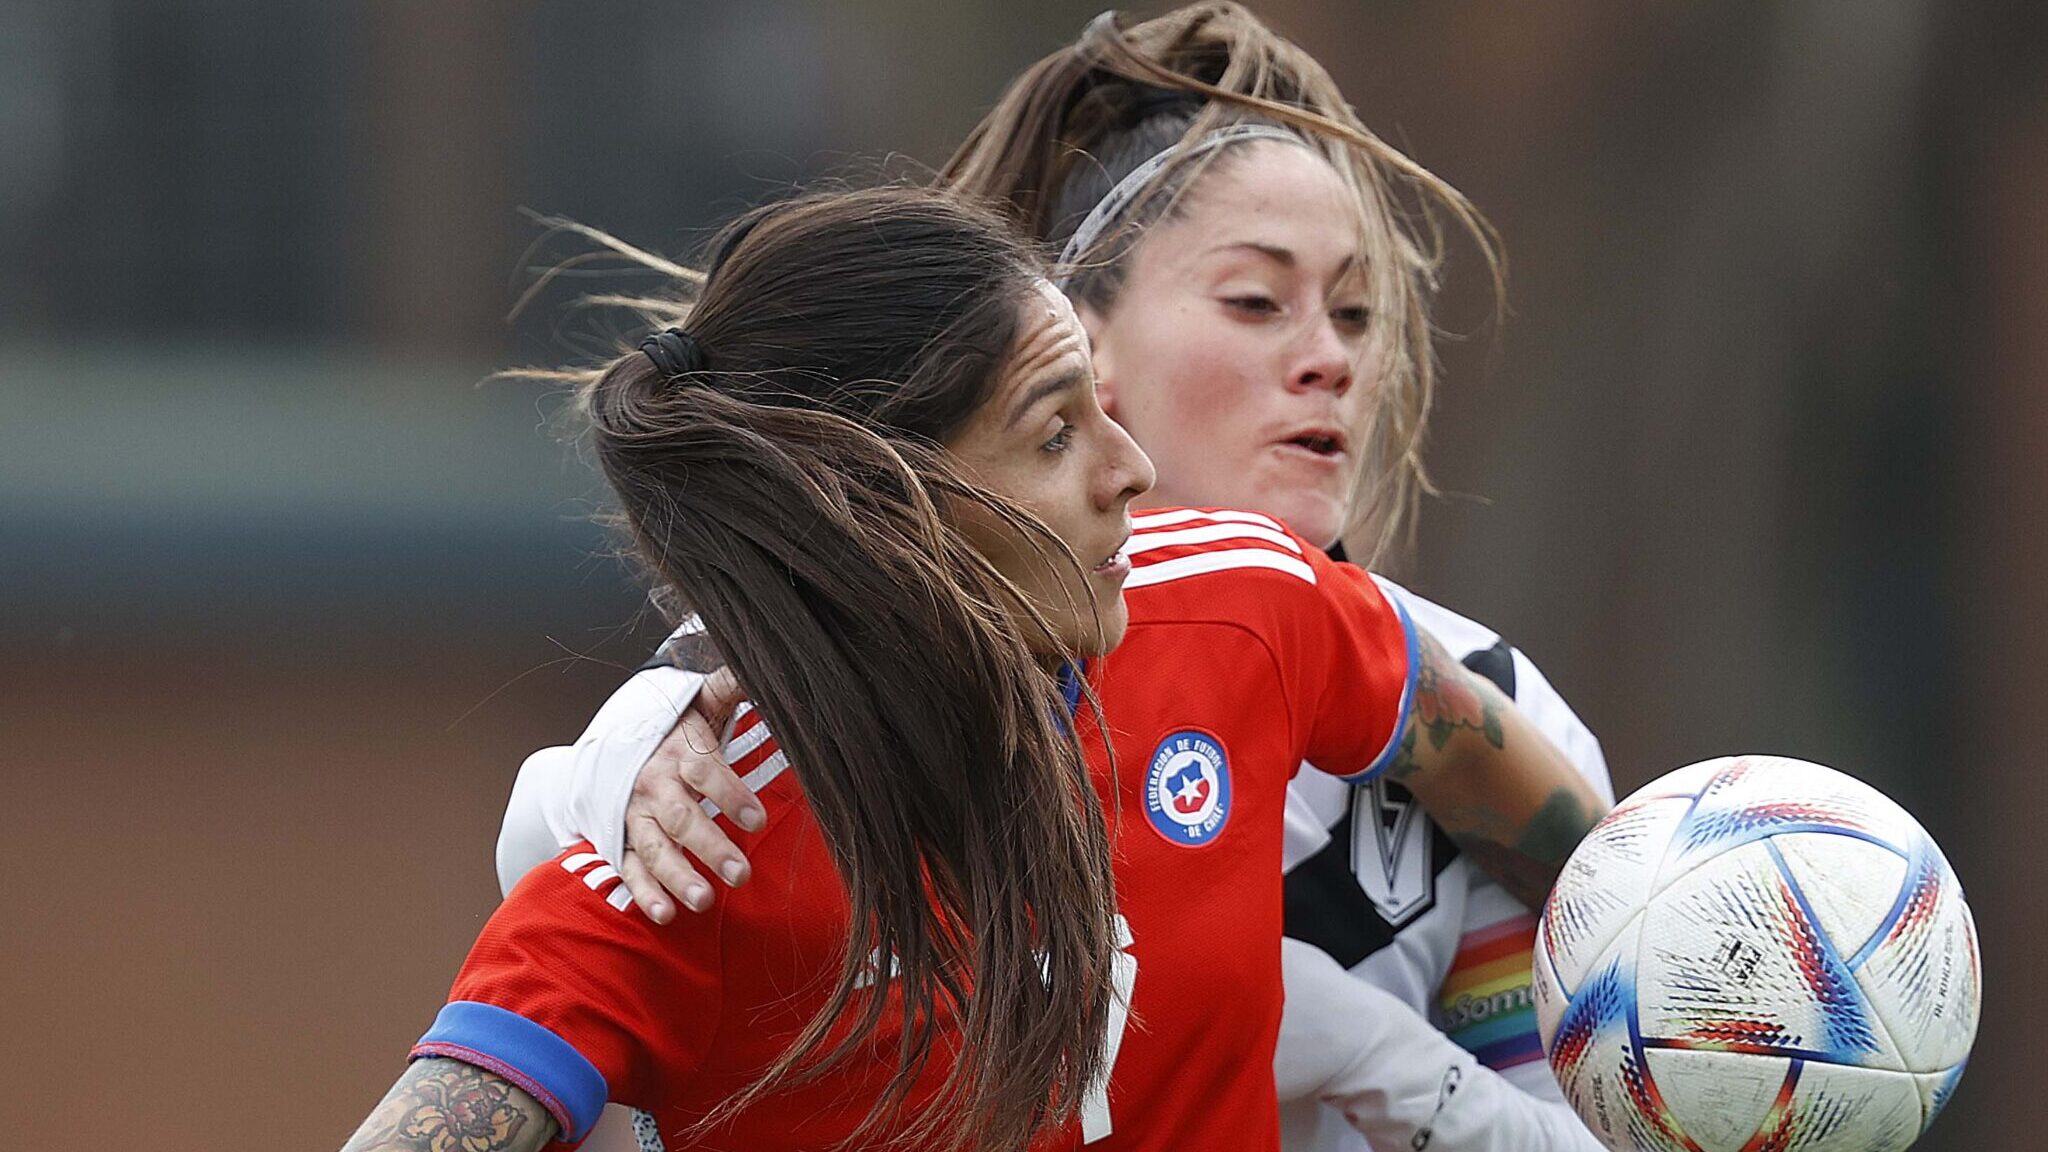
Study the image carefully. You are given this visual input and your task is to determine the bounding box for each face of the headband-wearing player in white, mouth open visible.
[1081,141,1378,545]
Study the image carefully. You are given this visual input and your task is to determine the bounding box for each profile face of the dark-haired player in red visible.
[946,281,1153,656]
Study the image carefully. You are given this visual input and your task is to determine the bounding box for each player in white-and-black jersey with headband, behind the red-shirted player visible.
[500,4,1612,1152]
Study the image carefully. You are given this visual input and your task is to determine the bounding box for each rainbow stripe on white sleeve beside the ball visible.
[1438,914,1542,1070]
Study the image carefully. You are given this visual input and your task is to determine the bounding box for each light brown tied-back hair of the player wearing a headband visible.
[942,2,1503,564]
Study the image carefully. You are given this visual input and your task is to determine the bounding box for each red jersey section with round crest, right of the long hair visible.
[1079,510,1415,1152]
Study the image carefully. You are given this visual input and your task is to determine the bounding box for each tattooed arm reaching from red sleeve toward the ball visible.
[1386,631,1608,908]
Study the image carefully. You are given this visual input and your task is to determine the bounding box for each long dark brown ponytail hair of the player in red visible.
[512,187,1116,1148]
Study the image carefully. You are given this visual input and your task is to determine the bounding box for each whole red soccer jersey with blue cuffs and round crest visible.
[414,510,1415,1152]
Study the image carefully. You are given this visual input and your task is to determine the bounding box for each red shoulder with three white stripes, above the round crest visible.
[1124,508,1321,617]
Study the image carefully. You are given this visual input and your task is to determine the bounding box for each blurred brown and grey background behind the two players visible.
[0,0,2048,1150]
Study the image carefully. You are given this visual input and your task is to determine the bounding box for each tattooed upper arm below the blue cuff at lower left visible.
[342,1060,555,1152]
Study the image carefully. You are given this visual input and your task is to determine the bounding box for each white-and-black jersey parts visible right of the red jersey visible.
[1276,582,1614,1152]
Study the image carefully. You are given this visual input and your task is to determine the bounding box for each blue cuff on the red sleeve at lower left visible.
[412,1000,610,1144]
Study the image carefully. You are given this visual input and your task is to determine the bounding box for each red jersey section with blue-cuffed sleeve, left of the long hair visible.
[412,703,970,1152]
